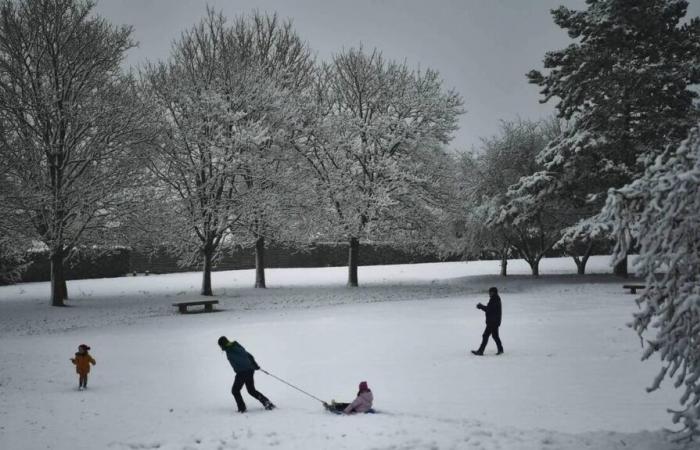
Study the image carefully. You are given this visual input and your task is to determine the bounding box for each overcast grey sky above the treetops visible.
[97,0,700,149]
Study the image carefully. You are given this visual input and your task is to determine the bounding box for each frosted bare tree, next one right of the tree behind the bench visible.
[225,11,315,288]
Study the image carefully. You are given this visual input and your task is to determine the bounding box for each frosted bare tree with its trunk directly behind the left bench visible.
[142,11,242,295]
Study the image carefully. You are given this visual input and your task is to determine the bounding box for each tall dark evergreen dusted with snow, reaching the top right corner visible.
[527,0,700,274]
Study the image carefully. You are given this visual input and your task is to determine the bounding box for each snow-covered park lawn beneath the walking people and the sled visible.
[0,257,692,450]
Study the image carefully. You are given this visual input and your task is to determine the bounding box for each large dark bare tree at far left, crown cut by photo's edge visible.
[0,0,149,306]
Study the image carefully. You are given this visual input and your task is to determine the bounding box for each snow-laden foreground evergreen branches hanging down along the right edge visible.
[607,126,700,439]
